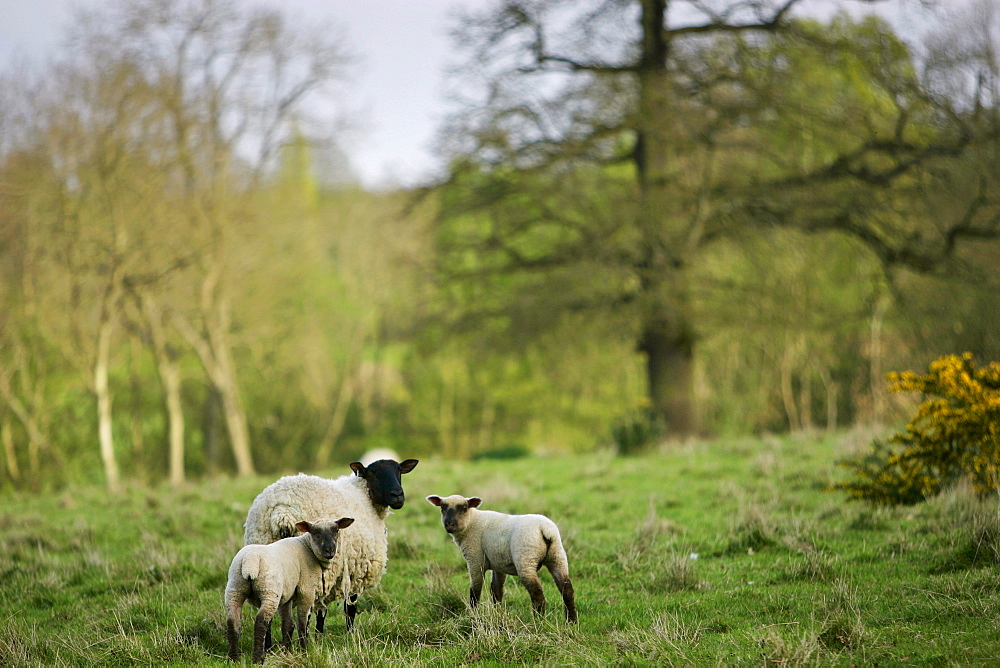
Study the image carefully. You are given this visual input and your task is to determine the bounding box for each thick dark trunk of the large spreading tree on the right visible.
[635,0,698,436]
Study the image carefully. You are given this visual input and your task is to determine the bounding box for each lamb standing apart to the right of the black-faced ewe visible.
[427,494,576,622]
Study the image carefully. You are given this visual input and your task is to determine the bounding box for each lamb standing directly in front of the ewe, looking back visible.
[225,517,354,663]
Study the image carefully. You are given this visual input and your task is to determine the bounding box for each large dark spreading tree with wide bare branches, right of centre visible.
[439,0,998,435]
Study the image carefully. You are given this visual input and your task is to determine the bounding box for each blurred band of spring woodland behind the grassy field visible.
[0,0,1000,491]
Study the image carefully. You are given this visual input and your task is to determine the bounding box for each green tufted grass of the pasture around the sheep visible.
[0,435,1000,666]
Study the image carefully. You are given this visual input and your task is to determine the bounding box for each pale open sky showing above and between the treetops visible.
[0,0,970,188]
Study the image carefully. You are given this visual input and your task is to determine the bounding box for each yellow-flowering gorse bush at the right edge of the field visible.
[836,353,1000,506]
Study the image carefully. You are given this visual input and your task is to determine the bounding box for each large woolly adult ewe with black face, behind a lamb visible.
[243,459,417,633]
